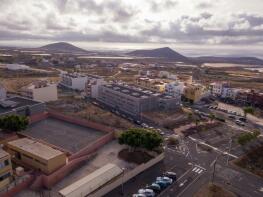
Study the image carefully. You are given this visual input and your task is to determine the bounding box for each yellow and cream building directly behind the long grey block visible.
[136,78,166,93]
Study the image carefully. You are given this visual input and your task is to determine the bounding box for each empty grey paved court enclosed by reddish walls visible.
[23,118,105,153]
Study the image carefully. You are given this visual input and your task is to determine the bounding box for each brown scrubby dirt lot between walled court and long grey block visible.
[48,96,134,129]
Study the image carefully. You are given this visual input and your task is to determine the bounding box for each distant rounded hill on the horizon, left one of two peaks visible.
[40,42,87,53]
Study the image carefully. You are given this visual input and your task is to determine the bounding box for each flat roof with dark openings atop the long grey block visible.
[103,84,159,98]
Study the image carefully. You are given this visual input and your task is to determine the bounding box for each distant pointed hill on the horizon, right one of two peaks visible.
[128,47,188,62]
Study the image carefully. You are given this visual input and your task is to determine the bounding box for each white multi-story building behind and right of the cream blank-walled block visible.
[60,73,88,91]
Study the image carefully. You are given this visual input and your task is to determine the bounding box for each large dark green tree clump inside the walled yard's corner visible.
[119,128,163,150]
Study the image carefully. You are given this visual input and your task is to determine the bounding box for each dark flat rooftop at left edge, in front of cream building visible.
[0,97,40,114]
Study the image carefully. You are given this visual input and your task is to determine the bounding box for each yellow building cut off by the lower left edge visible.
[0,149,13,190]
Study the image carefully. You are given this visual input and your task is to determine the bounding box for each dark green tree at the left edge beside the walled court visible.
[0,115,29,133]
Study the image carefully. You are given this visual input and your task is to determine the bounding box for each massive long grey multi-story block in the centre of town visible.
[98,84,181,118]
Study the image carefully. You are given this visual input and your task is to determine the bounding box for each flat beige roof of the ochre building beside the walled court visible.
[8,138,64,160]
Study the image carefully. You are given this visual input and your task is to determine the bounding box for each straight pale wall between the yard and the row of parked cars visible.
[91,153,164,197]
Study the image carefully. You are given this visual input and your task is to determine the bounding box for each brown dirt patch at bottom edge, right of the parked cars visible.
[194,184,236,197]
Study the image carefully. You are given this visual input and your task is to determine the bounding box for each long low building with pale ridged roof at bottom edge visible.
[59,163,123,197]
